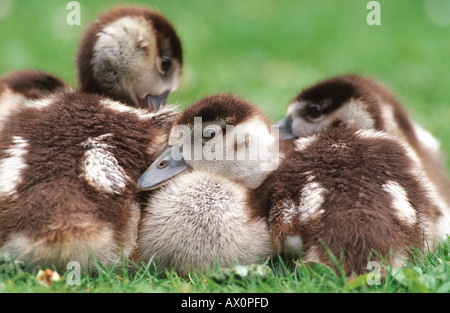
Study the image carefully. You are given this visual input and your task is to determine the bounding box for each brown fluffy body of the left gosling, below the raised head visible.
[0,92,178,270]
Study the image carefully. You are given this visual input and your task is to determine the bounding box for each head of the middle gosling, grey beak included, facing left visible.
[138,95,278,190]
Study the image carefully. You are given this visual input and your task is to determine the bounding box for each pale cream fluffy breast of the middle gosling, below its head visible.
[138,171,273,271]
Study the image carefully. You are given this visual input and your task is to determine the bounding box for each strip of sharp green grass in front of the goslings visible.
[0,239,450,293]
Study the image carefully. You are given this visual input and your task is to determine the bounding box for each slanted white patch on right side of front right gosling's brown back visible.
[382,181,417,226]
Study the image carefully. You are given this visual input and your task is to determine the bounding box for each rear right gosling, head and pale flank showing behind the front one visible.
[278,75,450,207]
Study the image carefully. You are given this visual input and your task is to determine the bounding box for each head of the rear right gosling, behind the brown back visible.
[277,75,406,137]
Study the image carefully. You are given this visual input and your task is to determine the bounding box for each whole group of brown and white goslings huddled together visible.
[0,7,450,275]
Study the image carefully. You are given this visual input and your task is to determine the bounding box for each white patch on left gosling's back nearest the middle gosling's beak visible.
[81,134,131,194]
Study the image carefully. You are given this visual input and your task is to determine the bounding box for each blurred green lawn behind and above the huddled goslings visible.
[0,0,450,165]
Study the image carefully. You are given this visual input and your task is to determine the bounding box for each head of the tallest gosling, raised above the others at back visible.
[77,7,183,110]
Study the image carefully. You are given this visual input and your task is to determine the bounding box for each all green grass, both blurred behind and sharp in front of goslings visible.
[0,0,450,292]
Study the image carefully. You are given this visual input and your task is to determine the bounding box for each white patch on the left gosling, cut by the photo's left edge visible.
[0,136,29,197]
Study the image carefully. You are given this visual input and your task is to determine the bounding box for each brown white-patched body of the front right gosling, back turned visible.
[253,125,450,275]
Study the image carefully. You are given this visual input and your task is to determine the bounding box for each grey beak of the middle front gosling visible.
[138,145,189,191]
